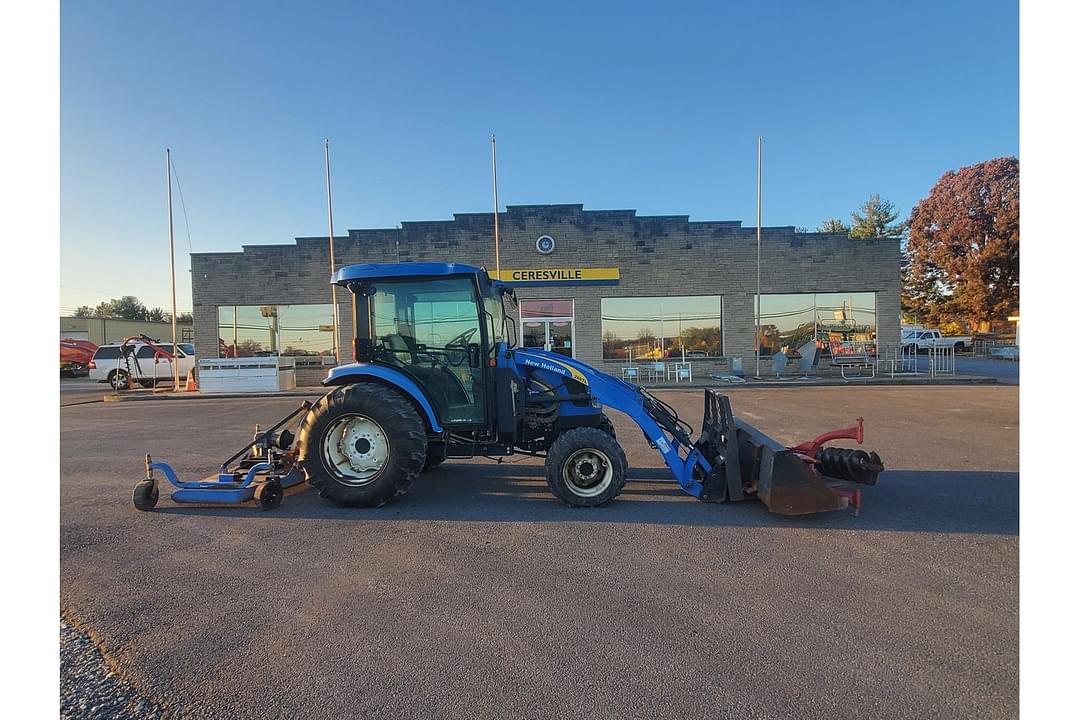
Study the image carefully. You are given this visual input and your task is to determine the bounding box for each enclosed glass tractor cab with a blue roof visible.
[334,262,505,429]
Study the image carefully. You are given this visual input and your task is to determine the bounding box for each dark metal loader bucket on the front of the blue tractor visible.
[696,390,859,515]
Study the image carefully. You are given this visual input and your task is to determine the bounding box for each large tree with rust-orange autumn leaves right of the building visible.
[903,158,1020,327]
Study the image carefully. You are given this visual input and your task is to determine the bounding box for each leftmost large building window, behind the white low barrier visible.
[217,302,335,365]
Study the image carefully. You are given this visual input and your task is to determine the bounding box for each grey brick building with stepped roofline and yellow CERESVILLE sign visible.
[191,205,900,382]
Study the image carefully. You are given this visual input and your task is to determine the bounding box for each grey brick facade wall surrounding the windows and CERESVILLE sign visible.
[191,205,900,364]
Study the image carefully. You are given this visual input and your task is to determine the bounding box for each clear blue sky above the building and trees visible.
[60,0,1020,311]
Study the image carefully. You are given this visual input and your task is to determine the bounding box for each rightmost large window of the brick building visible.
[755,293,877,355]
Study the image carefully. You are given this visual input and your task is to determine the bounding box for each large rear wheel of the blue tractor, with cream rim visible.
[297,382,428,507]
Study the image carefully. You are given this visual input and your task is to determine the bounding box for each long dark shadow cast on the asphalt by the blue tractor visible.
[156,462,1020,535]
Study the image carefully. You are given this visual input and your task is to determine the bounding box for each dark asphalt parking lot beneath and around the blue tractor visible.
[60,385,1018,719]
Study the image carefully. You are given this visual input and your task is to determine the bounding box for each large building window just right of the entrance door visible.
[600,295,724,361]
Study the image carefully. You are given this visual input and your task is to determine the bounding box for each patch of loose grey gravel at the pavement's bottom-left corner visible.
[60,616,165,720]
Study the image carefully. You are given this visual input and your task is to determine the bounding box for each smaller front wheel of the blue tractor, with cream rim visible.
[544,427,626,507]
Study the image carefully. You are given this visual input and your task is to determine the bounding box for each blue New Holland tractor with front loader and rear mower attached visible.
[134,262,883,515]
